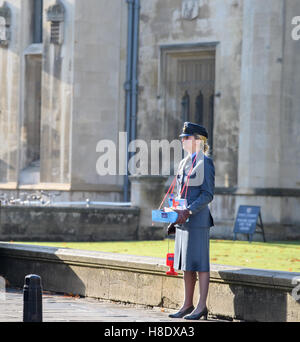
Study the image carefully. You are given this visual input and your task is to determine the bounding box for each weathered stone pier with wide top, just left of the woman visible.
[129,175,168,240]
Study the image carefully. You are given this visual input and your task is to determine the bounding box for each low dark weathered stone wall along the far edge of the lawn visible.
[0,206,300,242]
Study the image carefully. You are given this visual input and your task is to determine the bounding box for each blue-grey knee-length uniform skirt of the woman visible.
[174,225,210,272]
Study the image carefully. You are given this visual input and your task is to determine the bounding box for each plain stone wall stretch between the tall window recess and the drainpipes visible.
[70,0,127,196]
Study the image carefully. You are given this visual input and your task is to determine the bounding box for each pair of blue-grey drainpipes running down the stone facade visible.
[124,0,140,202]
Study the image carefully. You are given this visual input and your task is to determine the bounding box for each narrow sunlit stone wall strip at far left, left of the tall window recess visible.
[0,0,24,184]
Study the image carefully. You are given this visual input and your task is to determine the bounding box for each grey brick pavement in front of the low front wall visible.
[0,290,225,323]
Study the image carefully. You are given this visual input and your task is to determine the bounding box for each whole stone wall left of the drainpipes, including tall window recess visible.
[0,0,127,201]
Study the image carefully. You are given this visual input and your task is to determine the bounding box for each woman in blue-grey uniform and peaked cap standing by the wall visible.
[168,122,215,320]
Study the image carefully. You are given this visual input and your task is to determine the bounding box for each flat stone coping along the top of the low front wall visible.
[0,242,300,292]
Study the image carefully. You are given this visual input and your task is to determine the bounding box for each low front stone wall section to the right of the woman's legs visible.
[210,268,300,322]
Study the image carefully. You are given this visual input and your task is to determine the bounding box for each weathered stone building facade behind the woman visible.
[0,0,300,238]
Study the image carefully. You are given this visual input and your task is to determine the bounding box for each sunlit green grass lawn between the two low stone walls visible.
[12,240,300,272]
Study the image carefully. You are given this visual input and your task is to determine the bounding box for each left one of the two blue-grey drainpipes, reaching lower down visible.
[124,0,134,202]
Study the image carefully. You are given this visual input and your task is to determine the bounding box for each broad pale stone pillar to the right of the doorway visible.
[238,0,284,189]
